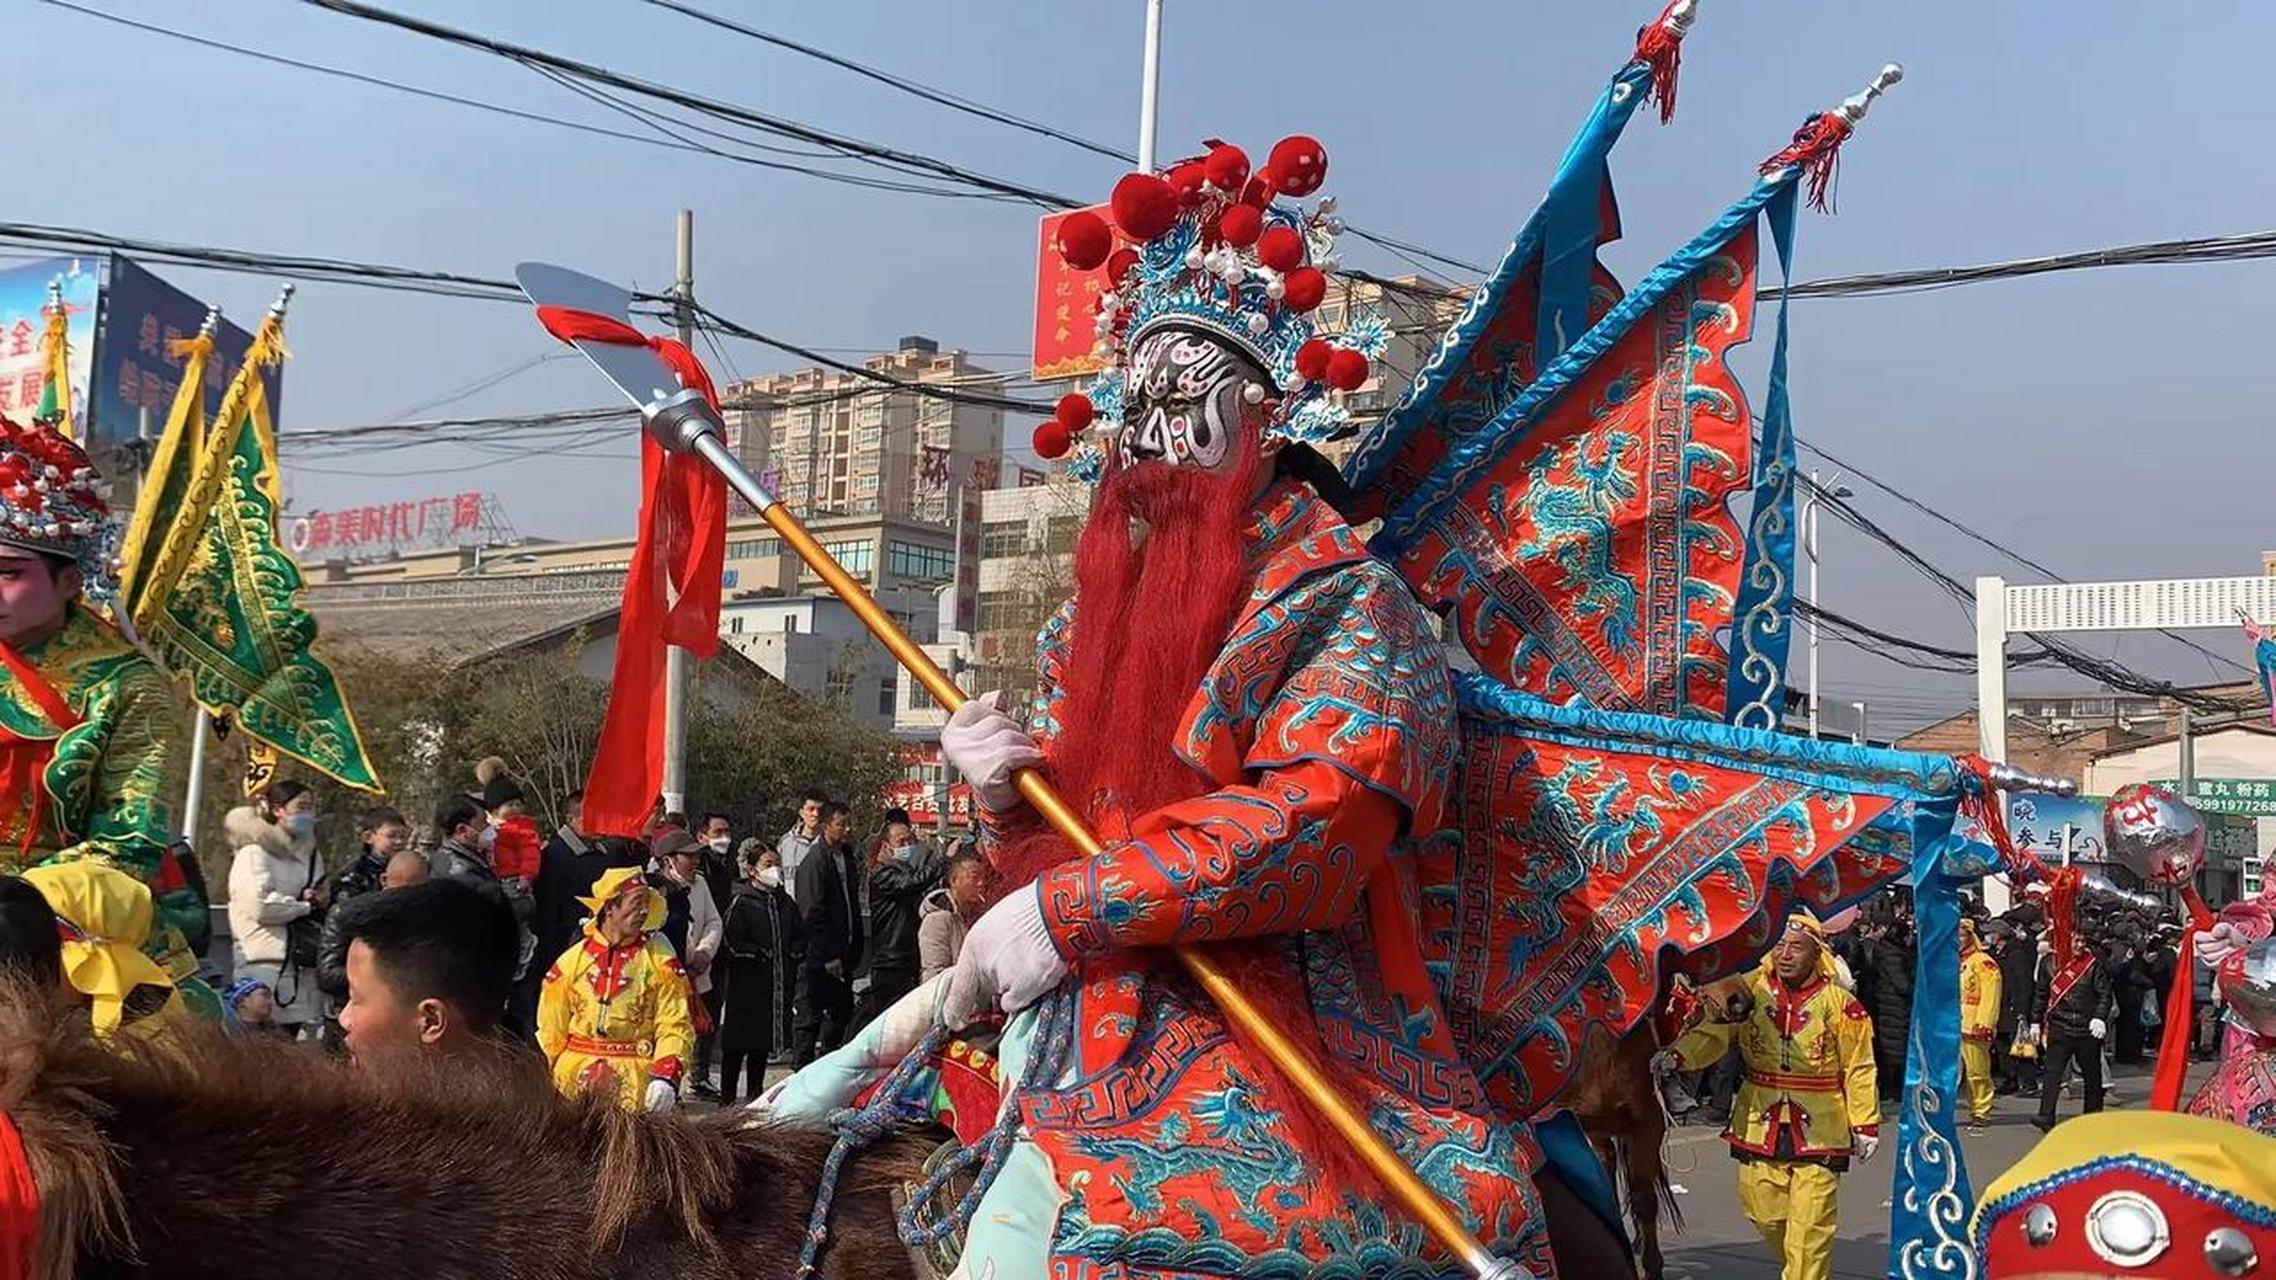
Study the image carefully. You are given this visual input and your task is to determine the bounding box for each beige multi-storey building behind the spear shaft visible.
[721,337,1004,526]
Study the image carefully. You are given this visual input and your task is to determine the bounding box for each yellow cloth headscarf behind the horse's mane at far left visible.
[23,861,182,1036]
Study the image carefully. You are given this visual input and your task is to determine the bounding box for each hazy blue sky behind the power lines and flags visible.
[17,0,2276,713]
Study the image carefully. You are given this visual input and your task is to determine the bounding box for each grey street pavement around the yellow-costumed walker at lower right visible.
[1659,1064,2210,1280]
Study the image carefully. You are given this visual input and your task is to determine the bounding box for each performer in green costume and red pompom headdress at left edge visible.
[0,419,221,1018]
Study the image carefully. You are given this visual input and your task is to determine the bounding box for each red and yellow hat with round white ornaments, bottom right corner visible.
[1971,1111,2276,1280]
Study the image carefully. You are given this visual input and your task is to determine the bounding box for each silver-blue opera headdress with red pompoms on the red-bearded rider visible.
[1036,134,1388,471]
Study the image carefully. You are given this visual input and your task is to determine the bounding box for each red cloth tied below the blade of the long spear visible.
[537,307,726,836]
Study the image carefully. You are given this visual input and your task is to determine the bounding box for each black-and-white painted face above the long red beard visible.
[1120,328,1270,471]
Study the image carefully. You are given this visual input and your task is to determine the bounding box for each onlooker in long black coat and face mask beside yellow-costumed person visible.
[719,838,806,1105]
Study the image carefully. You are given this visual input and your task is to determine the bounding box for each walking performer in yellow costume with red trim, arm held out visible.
[1661,916,1880,1280]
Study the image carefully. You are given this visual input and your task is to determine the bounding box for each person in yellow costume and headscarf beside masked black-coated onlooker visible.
[537,868,696,1111]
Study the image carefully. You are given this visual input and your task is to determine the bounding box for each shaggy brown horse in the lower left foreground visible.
[0,986,926,1280]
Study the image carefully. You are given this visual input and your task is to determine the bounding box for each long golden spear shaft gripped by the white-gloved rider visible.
[642,392,1523,1280]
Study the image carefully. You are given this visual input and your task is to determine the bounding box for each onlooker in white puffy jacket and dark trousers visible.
[221,781,332,1034]
